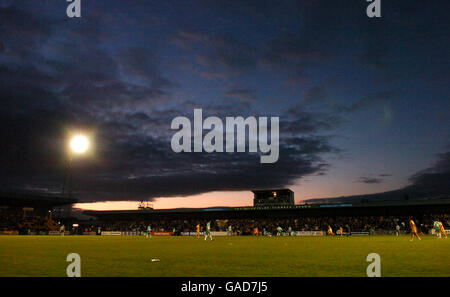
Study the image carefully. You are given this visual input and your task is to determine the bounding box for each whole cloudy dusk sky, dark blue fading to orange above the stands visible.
[0,0,450,209]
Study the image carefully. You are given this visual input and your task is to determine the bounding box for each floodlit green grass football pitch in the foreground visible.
[0,235,450,277]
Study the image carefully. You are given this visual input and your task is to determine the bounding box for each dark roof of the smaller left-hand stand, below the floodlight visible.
[0,192,77,207]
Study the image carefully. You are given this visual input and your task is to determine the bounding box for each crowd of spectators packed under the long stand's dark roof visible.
[92,214,450,235]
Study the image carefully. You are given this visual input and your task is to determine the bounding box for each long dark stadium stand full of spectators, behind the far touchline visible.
[84,194,450,235]
